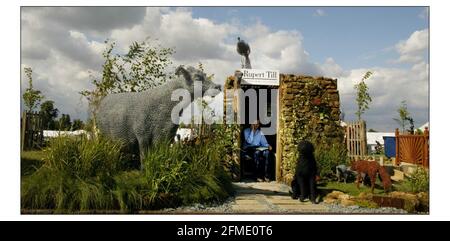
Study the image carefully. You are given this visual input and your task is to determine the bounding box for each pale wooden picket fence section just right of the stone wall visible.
[345,121,367,160]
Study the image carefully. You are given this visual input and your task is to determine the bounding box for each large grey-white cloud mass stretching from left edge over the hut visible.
[21,7,329,120]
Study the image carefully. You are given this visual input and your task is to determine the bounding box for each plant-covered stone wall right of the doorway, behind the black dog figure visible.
[278,74,346,183]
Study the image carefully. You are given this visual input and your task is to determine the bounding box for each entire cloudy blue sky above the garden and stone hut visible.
[21,7,429,132]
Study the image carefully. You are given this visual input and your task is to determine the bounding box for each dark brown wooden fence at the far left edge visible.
[20,111,44,151]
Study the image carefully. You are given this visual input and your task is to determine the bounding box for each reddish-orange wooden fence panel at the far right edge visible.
[395,128,429,168]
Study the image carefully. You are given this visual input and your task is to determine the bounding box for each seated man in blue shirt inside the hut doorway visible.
[243,120,272,181]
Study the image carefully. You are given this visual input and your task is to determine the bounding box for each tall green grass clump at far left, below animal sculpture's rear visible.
[21,137,122,211]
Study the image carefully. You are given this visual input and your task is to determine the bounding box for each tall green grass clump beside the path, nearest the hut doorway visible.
[115,137,232,210]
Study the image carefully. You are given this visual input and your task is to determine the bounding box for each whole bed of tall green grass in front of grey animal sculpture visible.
[21,131,232,213]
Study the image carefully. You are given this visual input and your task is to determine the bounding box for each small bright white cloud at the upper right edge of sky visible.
[394,29,428,63]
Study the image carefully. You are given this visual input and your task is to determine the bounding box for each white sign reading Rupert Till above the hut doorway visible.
[241,69,280,85]
